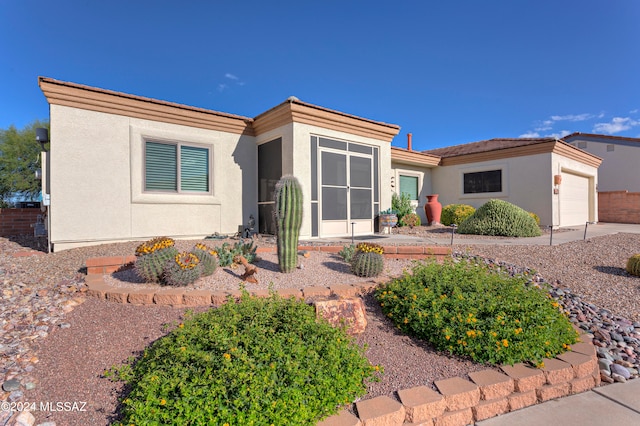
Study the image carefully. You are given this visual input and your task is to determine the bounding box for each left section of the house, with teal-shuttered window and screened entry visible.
[39,77,399,251]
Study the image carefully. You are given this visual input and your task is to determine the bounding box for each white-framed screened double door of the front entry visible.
[320,149,373,237]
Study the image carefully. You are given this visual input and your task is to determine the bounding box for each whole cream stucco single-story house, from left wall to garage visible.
[39,77,600,251]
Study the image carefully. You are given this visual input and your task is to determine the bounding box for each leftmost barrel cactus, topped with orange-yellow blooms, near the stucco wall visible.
[134,237,178,283]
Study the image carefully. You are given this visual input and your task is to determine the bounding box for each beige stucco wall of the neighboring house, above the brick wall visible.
[571,139,640,192]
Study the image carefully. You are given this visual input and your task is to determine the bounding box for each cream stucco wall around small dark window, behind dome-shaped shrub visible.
[432,154,553,225]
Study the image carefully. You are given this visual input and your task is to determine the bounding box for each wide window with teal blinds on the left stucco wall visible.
[144,141,211,193]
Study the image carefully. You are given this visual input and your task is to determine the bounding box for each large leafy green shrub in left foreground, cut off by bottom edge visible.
[107,292,379,425]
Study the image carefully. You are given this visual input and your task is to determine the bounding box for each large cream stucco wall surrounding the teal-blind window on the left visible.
[50,105,257,251]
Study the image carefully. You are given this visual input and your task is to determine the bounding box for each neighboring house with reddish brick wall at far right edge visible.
[563,133,640,223]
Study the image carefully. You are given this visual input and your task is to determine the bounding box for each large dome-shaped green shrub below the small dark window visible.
[458,200,541,237]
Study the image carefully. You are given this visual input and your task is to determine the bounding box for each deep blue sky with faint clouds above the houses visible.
[0,0,640,150]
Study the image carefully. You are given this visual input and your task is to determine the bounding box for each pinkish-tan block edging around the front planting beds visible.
[81,246,600,426]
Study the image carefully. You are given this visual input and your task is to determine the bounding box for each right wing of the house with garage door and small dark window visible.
[391,138,601,226]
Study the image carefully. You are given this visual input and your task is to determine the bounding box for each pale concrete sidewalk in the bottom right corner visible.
[476,379,640,426]
